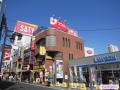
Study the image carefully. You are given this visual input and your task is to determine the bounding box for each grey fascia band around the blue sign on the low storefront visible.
[69,51,120,66]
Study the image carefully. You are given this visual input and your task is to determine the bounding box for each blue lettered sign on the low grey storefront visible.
[94,56,117,63]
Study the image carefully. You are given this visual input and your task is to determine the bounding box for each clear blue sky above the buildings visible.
[6,0,120,54]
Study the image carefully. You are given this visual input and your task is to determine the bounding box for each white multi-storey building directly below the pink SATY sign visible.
[9,32,31,80]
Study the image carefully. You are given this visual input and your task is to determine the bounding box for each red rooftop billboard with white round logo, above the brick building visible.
[50,17,68,32]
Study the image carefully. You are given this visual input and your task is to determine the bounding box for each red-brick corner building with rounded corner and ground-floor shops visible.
[33,29,84,82]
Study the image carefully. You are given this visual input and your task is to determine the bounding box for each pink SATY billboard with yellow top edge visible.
[15,21,38,36]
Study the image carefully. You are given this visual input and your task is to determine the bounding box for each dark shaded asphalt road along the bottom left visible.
[0,81,59,90]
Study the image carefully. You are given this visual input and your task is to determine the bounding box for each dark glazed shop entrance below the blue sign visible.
[96,64,120,84]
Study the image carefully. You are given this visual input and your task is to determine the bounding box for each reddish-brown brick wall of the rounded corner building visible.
[35,29,84,78]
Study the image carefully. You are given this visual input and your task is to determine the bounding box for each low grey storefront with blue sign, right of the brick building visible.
[69,52,120,87]
